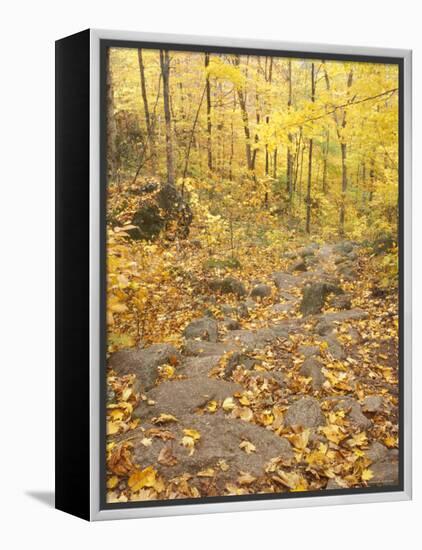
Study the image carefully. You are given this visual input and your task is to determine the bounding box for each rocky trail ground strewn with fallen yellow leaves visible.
[107,237,399,502]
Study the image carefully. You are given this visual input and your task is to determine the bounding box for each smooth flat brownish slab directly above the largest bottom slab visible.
[135,376,242,420]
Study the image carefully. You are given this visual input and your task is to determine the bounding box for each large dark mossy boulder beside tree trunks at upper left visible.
[128,183,193,240]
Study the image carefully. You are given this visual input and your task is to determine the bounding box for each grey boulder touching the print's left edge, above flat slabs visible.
[108,344,181,392]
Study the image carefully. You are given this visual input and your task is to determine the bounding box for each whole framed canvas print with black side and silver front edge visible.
[56,30,411,520]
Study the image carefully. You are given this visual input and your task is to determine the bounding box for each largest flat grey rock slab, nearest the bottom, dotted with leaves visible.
[130,413,293,487]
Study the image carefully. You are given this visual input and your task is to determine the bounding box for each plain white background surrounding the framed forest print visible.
[0,0,422,550]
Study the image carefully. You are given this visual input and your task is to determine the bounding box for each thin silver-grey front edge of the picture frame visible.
[89,29,412,521]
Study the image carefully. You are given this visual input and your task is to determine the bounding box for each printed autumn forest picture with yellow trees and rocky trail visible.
[103,47,399,503]
